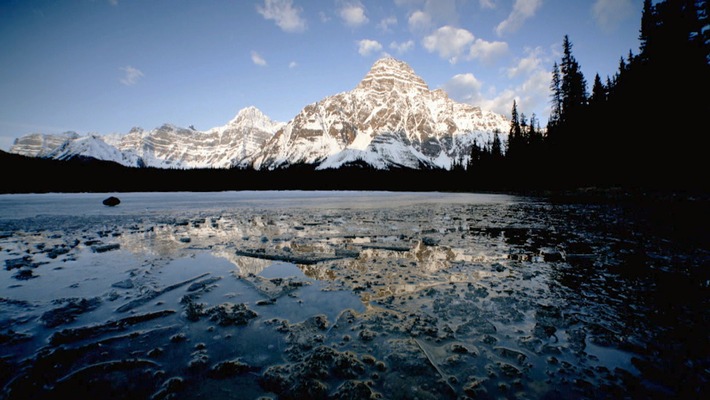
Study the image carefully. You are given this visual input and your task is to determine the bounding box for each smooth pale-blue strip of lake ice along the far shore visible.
[0,191,513,219]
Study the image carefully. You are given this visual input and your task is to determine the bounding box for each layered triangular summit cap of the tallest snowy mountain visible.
[356,57,429,92]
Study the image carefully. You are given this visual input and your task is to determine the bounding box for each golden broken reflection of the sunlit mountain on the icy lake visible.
[112,213,506,293]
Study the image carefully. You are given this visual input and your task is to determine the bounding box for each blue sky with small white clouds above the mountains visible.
[0,0,643,150]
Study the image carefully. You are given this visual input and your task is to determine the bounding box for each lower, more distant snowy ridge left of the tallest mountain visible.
[10,107,283,168]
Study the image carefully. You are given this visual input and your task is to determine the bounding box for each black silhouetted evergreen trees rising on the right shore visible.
[469,0,710,188]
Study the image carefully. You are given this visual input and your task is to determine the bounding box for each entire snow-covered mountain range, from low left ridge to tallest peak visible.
[10,57,510,170]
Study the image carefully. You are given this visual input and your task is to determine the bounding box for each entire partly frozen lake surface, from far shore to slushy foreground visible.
[0,192,710,399]
